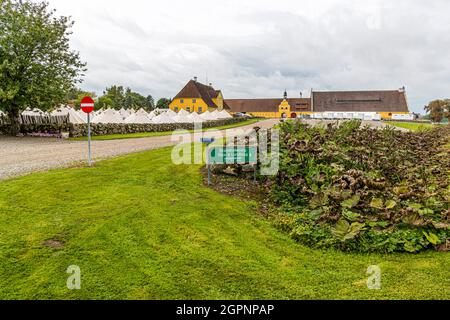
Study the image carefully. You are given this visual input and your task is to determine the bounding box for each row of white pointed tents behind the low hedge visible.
[22,106,232,124]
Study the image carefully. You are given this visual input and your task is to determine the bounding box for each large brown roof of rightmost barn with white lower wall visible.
[312,90,409,112]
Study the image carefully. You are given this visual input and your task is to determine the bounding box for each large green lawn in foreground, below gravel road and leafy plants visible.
[0,148,450,299]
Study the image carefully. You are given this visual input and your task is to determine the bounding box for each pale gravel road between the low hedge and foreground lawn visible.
[0,120,278,179]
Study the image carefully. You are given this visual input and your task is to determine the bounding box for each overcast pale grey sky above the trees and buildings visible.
[46,0,450,112]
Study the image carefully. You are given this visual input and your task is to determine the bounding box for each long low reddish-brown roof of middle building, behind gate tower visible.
[224,98,311,112]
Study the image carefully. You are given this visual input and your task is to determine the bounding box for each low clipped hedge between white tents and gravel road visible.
[0,118,246,138]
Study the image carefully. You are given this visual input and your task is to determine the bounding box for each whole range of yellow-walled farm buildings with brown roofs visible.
[169,79,410,119]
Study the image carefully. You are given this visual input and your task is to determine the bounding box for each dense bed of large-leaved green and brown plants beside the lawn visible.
[269,121,450,252]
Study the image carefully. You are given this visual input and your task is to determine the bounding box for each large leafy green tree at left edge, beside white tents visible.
[0,0,86,135]
